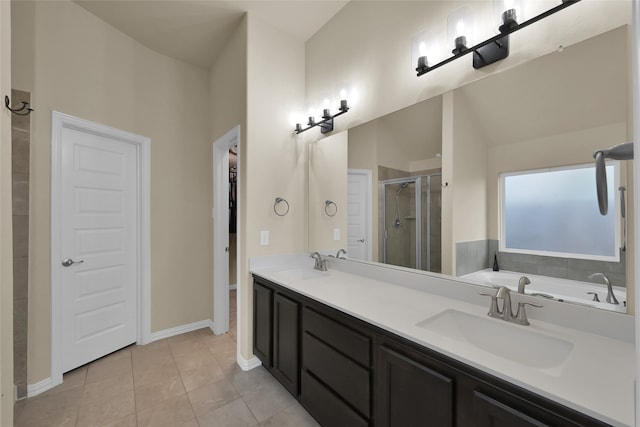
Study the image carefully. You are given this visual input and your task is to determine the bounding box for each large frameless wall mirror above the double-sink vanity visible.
[309,26,634,312]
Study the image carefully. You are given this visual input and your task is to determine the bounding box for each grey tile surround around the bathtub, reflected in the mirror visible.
[456,240,627,286]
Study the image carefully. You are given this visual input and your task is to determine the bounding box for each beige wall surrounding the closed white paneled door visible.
[12,1,212,384]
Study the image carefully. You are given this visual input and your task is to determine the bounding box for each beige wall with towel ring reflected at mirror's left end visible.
[309,131,348,251]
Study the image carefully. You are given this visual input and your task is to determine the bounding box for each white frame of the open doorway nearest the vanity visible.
[212,125,242,341]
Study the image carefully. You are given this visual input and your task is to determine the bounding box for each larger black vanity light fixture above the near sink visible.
[415,0,580,77]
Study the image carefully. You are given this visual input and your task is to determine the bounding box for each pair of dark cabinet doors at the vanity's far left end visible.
[253,281,300,396]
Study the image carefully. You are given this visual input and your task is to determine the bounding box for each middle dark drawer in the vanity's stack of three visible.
[302,333,371,418]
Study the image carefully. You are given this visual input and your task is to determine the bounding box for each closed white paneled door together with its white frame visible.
[50,112,151,394]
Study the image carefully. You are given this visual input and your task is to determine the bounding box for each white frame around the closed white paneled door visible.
[50,111,151,387]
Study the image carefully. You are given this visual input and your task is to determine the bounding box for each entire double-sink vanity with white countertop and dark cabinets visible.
[251,260,634,426]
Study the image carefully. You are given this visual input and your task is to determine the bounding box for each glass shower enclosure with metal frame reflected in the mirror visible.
[380,173,442,273]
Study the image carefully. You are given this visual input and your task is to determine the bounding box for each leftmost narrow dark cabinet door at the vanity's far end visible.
[253,281,273,368]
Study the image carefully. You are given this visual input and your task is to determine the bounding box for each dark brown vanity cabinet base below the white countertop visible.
[253,276,607,427]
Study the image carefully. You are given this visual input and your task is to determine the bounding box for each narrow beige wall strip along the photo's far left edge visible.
[0,2,13,426]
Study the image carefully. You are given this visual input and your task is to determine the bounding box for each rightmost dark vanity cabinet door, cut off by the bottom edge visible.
[473,390,547,427]
